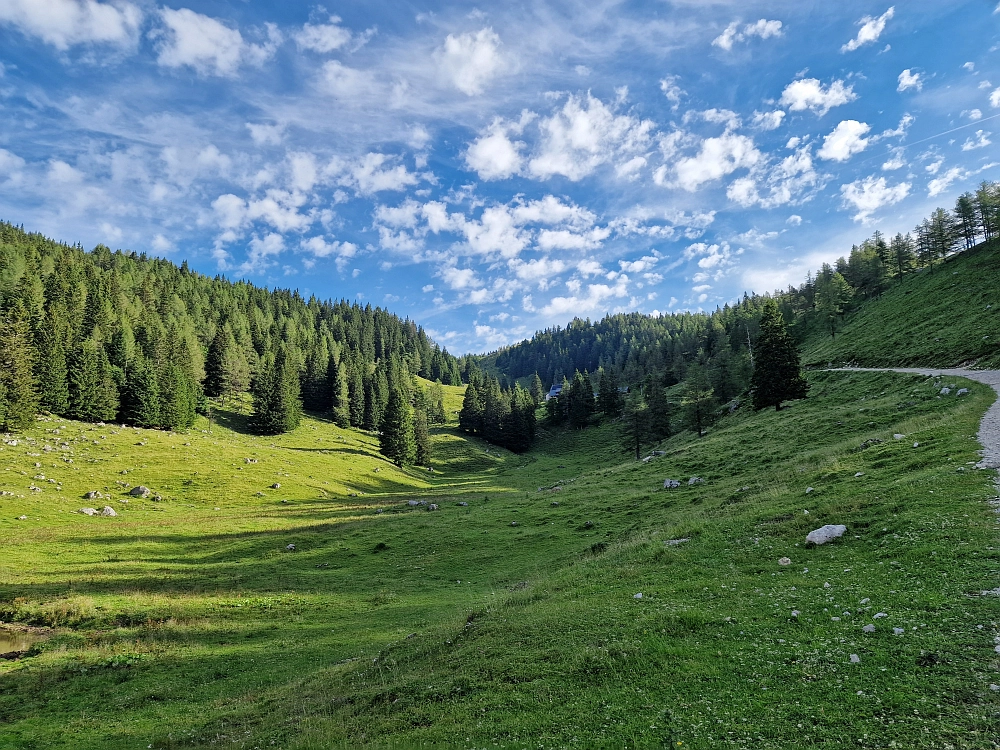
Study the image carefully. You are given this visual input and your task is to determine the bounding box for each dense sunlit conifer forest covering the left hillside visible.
[0,223,461,440]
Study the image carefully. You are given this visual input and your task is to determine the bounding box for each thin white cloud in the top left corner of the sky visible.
[0,0,142,51]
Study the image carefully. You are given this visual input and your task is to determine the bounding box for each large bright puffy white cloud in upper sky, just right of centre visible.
[528,93,653,181]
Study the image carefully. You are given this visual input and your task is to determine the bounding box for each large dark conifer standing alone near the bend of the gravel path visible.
[750,299,809,410]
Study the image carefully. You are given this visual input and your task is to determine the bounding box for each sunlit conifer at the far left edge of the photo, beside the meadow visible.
[0,301,38,431]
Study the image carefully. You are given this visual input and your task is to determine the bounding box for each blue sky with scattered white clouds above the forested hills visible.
[0,0,1000,352]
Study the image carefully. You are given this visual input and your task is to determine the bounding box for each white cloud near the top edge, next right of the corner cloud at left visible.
[156,8,281,76]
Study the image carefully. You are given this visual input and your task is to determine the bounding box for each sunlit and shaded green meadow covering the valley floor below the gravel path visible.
[0,373,1000,748]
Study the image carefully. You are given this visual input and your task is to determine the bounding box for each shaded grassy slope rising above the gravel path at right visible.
[803,242,1000,367]
